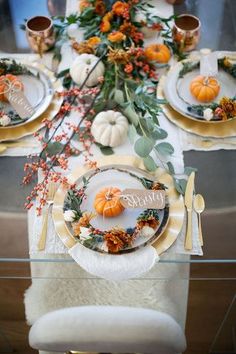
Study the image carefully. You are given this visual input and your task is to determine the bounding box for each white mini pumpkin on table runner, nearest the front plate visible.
[91,110,129,147]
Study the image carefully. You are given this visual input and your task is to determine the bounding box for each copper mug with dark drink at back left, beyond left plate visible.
[26,16,55,56]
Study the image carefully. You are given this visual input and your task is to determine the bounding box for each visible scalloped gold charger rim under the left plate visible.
[0,62,63,141]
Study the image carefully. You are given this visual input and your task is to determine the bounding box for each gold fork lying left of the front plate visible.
[38,182,57,251]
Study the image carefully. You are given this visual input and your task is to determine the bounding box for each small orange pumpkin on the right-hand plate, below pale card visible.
[190,75,220,102]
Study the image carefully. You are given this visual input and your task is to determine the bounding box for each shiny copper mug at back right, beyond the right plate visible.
[172,14,201,52]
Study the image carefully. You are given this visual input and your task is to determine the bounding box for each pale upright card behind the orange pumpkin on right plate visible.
[200,50,218,76]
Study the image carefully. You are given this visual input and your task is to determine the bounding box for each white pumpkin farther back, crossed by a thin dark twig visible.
[70,54,105,87]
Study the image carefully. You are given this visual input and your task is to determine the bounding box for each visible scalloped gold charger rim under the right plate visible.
[157,76,236,138]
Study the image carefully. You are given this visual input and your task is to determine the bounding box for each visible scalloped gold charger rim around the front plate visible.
[52,156,184,254]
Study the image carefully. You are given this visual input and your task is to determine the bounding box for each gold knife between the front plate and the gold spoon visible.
[184,172,195,250]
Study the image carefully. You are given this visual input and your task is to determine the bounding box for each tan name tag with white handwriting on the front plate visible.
[120,188,166,209]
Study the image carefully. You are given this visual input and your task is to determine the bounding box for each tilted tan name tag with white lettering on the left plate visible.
[4,82,35,119]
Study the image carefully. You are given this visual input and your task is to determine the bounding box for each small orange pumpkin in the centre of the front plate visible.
[94,187,124,218]
